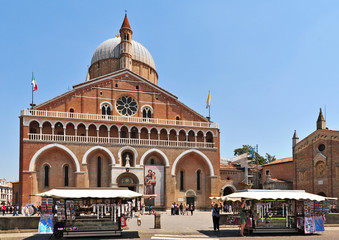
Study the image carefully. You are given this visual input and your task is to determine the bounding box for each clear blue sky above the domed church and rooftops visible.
[0,0,339,181]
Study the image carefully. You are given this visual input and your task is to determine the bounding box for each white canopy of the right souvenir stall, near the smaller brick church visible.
[211,189,326,201]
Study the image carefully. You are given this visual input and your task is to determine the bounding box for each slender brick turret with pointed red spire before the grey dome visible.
[120,13,133,71]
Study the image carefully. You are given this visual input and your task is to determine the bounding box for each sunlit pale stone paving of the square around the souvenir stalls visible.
[0,211,339,240]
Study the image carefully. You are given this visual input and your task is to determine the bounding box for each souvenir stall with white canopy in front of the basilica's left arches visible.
[38,188,142,237]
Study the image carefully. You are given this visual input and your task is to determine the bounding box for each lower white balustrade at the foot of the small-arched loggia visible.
[28,133,214,148]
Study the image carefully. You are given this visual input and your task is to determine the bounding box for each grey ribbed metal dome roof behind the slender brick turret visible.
[91,37,156,70]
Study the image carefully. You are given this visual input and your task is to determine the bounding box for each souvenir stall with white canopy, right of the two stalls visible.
[211,189,328,233]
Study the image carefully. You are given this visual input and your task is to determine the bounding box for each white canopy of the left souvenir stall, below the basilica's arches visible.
[37,188,142,198]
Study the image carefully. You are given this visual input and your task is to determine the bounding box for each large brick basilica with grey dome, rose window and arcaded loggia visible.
[20,16,220,208]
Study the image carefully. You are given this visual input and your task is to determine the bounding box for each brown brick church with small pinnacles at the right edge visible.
[293,109,339,201]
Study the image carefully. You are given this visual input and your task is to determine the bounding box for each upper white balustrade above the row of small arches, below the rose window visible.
[21,109,218,128]
